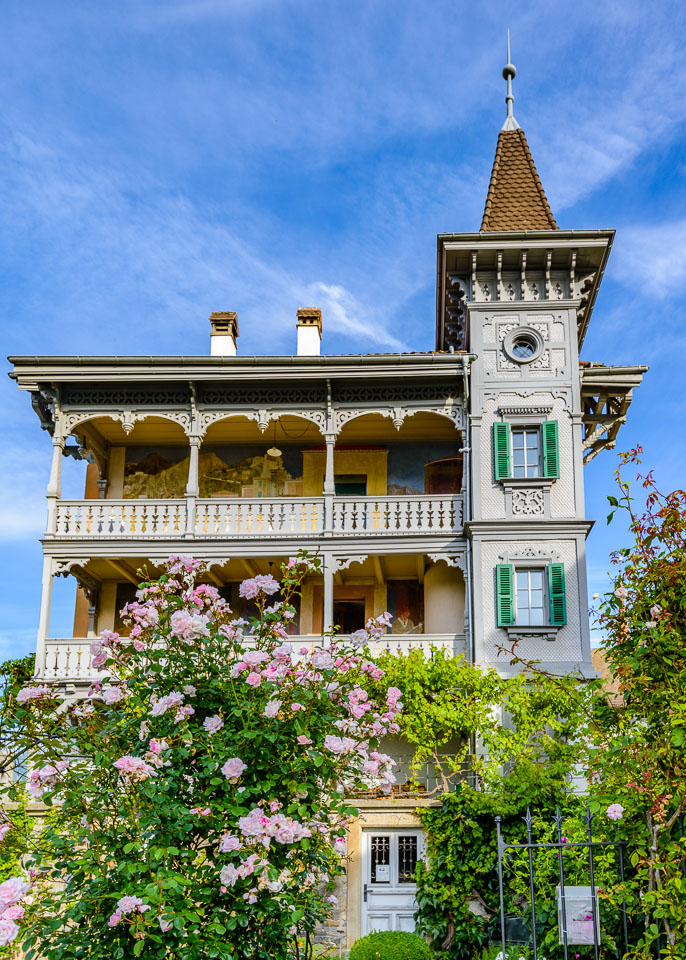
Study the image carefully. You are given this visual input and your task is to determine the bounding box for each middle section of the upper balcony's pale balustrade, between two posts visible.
[195,497,324,538]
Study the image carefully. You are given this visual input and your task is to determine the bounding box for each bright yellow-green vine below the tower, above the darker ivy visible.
[362,650,587,813]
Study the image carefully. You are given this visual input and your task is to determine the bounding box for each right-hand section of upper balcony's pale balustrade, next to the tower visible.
[332,494,462,536]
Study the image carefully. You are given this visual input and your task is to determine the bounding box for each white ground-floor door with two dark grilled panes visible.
[362,830,423,935]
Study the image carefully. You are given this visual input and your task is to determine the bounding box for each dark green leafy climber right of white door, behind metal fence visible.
[416,788,636,960]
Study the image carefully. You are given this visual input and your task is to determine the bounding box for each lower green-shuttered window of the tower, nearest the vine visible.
[495,563,567,627]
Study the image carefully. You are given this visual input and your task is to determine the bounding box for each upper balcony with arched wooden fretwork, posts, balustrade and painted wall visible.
[39,388,464,549]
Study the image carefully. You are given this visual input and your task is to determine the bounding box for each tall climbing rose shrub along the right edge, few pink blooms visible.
[588,448,686,958]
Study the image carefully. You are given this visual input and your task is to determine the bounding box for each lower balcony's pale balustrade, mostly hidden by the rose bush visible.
[36,633,467,683]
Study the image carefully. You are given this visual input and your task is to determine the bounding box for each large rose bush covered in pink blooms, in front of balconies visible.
[0,555,402,960]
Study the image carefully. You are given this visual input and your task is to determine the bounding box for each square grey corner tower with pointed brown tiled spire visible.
[436,38,645,676]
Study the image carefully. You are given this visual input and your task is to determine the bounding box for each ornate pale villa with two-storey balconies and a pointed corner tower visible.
[10,56,647,946]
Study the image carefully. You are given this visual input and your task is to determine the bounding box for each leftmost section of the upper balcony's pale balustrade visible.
[55,500,186,540]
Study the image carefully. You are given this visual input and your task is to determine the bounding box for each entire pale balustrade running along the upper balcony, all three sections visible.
[47,494,463,541]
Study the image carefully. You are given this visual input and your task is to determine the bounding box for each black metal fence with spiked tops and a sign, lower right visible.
[495,807,632,960]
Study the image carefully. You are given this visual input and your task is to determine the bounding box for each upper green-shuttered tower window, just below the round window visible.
[493,420,560,481]
